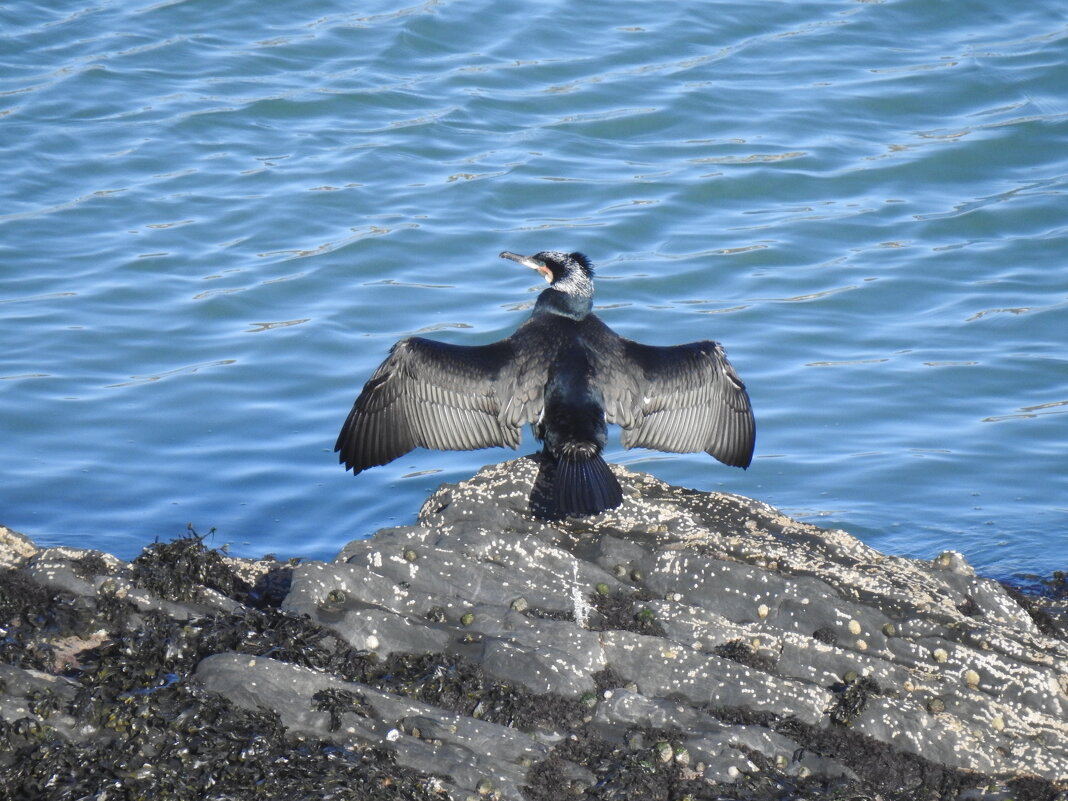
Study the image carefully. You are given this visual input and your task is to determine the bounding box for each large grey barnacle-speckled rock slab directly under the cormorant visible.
[311,459,1068,781]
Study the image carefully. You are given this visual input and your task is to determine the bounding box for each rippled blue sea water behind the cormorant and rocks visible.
[0,0,1068,577]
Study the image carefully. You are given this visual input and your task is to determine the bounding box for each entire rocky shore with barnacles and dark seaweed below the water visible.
[0,458,1068,801]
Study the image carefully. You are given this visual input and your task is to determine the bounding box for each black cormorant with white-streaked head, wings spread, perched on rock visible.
[334,251,755,517]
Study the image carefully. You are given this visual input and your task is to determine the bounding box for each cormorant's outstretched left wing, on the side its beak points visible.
[334,337,529,474]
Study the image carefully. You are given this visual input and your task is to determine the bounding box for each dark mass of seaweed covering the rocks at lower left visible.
[0,534,454,801]
